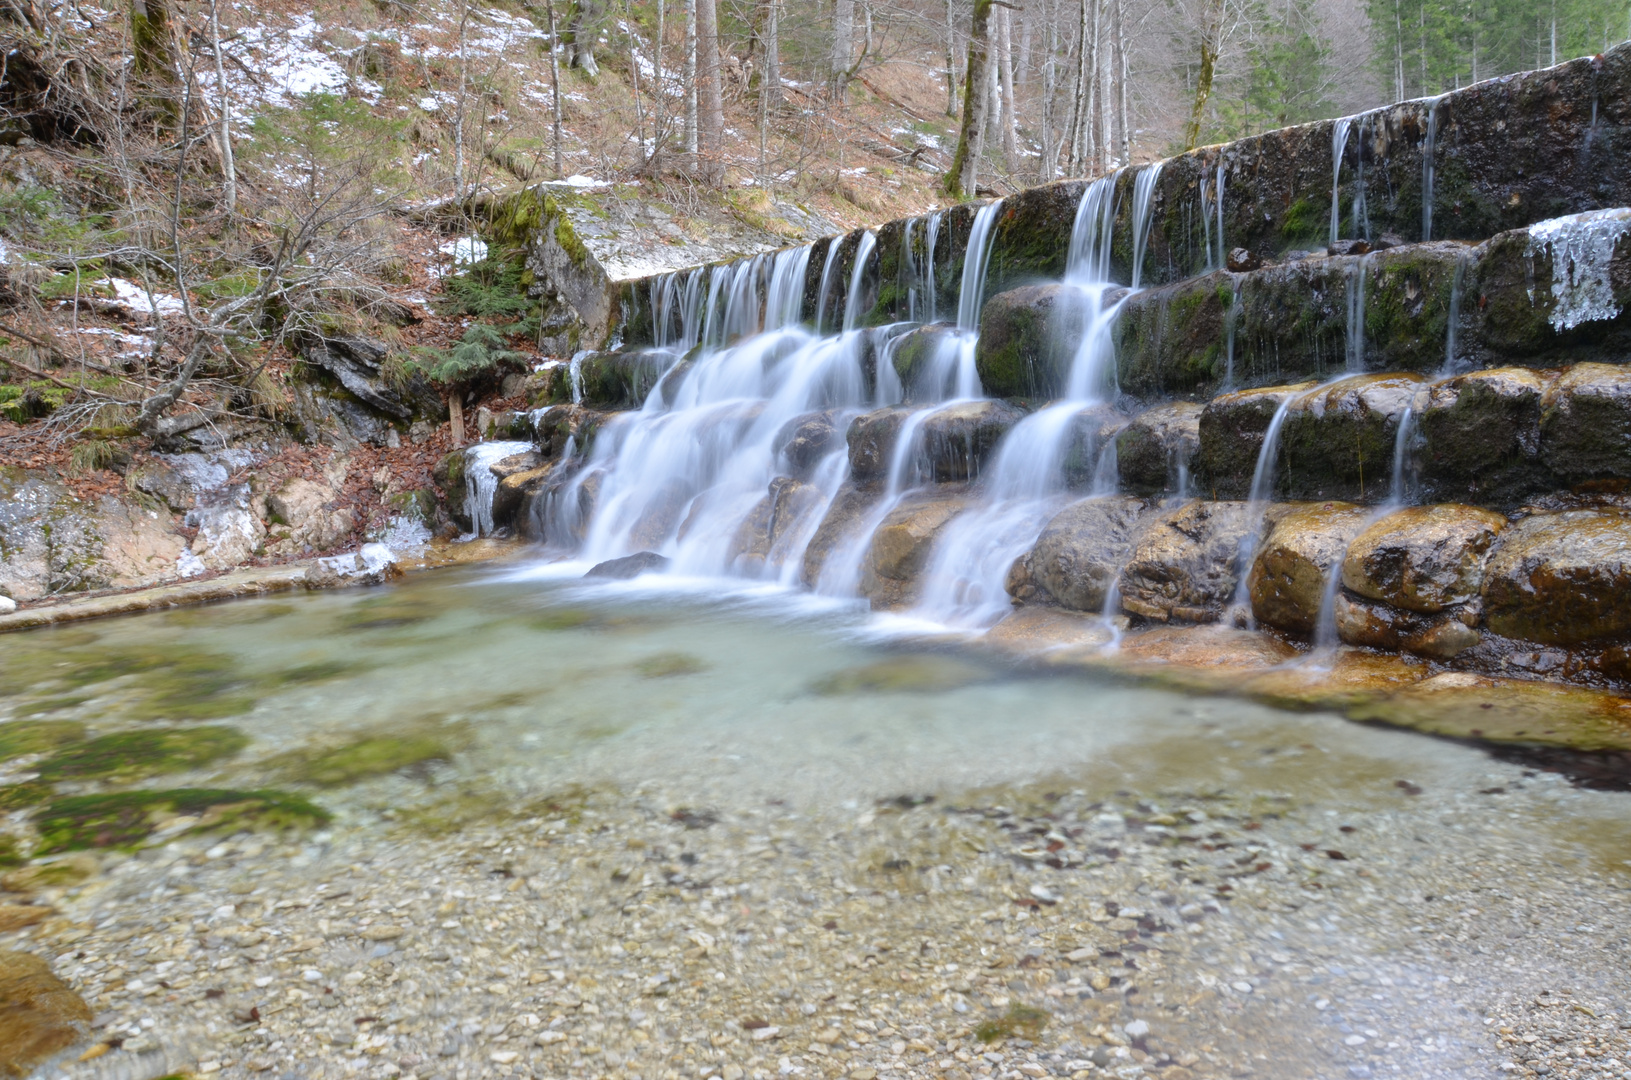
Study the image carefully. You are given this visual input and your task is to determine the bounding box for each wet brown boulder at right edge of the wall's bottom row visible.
[1483,511,1631,644]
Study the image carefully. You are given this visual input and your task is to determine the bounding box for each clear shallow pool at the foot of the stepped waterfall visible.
[0,563,1631,1080]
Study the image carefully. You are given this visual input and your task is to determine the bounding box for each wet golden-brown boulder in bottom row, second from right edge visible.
[1342,502,1507,615]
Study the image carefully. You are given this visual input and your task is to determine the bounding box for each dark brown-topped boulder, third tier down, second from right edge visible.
[1416,367,1556,506]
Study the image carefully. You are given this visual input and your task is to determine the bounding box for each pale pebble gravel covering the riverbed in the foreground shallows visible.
[0,730,1631,1080]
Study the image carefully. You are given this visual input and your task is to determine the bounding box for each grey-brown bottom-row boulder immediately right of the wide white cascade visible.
[1010,496,1150,612]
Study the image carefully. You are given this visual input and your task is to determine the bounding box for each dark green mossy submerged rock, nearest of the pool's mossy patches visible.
[34,788,329,855]
